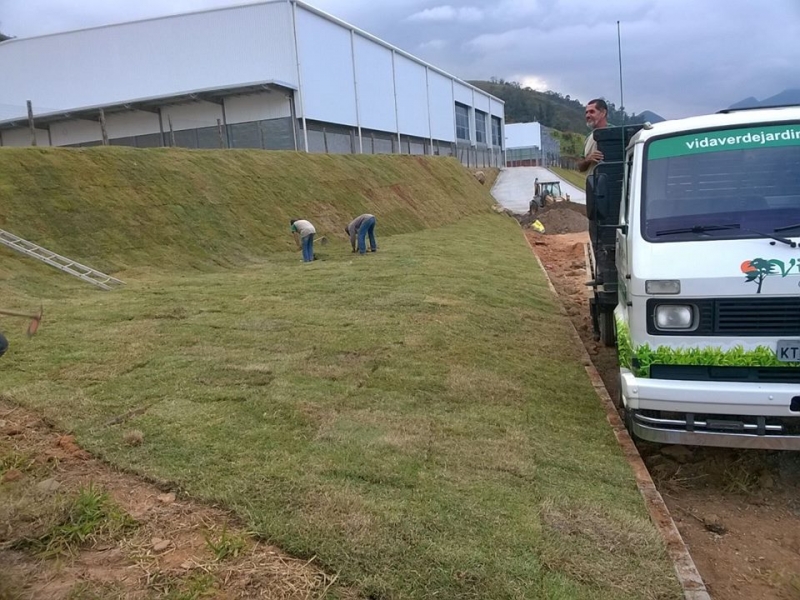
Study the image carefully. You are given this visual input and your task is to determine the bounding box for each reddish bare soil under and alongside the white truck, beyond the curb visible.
[525,209,800,600]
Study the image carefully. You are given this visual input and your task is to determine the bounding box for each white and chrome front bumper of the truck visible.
[620,370,800,450]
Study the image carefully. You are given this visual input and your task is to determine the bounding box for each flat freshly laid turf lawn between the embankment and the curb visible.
[0,214,680,600]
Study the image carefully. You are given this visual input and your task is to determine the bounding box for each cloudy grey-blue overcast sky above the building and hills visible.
[0,0,800,118]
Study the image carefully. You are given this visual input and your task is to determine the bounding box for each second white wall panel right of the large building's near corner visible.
[355,35,397,131]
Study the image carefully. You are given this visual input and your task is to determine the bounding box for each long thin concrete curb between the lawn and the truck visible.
[522,231,711,600]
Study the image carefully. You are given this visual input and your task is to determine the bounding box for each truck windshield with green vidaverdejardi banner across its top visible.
[642,123,800,242]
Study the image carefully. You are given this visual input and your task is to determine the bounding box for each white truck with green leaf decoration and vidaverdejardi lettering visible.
[587,106,800,450]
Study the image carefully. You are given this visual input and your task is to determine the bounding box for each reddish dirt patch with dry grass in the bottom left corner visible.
[0,399,356,600]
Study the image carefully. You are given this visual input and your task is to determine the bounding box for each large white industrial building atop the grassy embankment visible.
[0,0,505,166]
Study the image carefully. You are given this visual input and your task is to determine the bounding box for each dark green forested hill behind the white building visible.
[469,79,663,135]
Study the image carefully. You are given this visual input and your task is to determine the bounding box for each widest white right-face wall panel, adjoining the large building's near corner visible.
[296,6,356,126]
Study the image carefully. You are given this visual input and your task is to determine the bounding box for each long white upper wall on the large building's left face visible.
[0,2,297,120]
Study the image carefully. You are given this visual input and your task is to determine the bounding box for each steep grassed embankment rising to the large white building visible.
[0,148,491,273]
